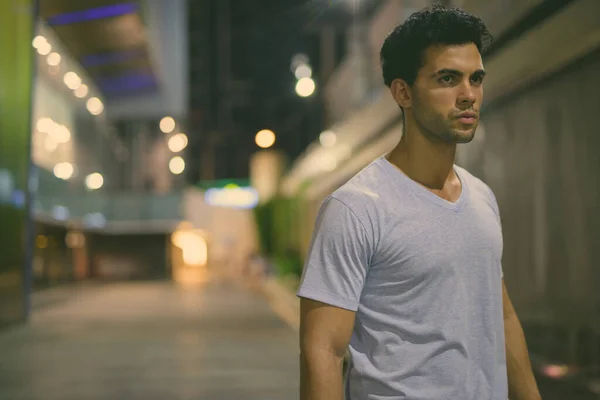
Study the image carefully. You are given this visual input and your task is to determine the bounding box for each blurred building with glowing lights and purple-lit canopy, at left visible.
[0,0,188,325]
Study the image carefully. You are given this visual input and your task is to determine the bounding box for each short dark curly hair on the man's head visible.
[380,5,493,86]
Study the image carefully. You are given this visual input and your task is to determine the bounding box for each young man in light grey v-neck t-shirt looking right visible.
[298,6,540,400]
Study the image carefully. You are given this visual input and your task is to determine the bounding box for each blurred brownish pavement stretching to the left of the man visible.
[0,282,298,400]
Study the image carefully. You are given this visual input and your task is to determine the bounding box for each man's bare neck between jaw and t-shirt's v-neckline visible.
[387,128,457,191]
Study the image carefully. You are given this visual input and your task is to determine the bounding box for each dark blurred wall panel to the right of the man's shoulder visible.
[459,47,600,328]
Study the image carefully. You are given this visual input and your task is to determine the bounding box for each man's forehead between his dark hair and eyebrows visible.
[422,43,483,74]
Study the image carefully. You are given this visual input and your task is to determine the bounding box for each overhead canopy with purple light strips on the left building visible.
[40,0,158,99]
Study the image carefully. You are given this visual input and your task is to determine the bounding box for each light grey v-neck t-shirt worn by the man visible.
[297,157,508,400]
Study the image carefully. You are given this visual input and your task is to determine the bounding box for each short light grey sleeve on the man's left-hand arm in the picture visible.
[297,197,372,311]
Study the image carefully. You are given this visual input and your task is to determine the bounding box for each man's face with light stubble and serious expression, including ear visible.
[406,44,485,143]
